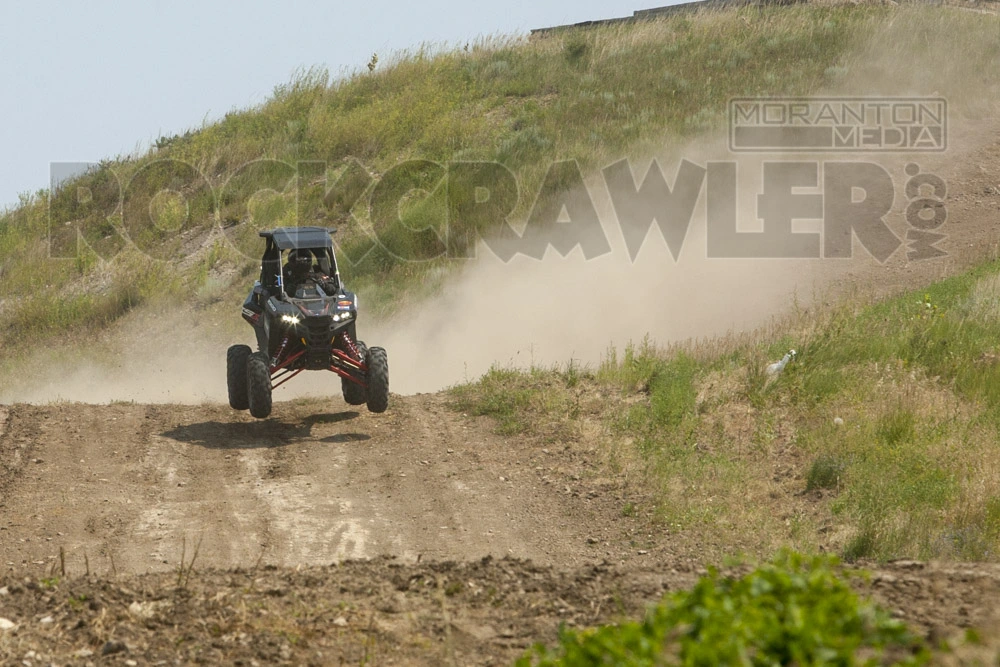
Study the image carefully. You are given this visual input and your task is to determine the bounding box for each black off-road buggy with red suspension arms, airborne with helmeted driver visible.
[226,227,389,419]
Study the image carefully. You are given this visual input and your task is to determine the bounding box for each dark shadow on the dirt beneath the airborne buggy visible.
[160,411,371,449]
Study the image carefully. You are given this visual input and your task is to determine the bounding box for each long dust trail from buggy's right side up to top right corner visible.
[369,3,1000,393]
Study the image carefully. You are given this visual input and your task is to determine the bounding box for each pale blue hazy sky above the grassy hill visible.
[0,0,675,209]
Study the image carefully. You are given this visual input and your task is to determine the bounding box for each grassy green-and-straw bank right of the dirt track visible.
[454,262,1000,562]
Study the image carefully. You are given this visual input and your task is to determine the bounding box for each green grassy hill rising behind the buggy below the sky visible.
[0,5,997,358]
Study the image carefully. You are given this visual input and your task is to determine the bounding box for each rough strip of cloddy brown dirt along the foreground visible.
[0,558,1000,665]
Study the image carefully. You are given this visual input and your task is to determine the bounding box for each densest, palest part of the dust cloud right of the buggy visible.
[368,163,836,393]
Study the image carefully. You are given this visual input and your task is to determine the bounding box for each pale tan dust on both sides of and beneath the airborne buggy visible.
[0,154,844,404]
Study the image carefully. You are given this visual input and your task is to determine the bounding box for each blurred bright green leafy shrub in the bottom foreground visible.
[516,552,929,667]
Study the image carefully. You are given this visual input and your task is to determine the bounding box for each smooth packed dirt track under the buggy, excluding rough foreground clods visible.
[0,395,636,575]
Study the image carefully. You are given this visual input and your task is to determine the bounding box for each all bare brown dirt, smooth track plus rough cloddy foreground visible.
[0,395,1000,665]
